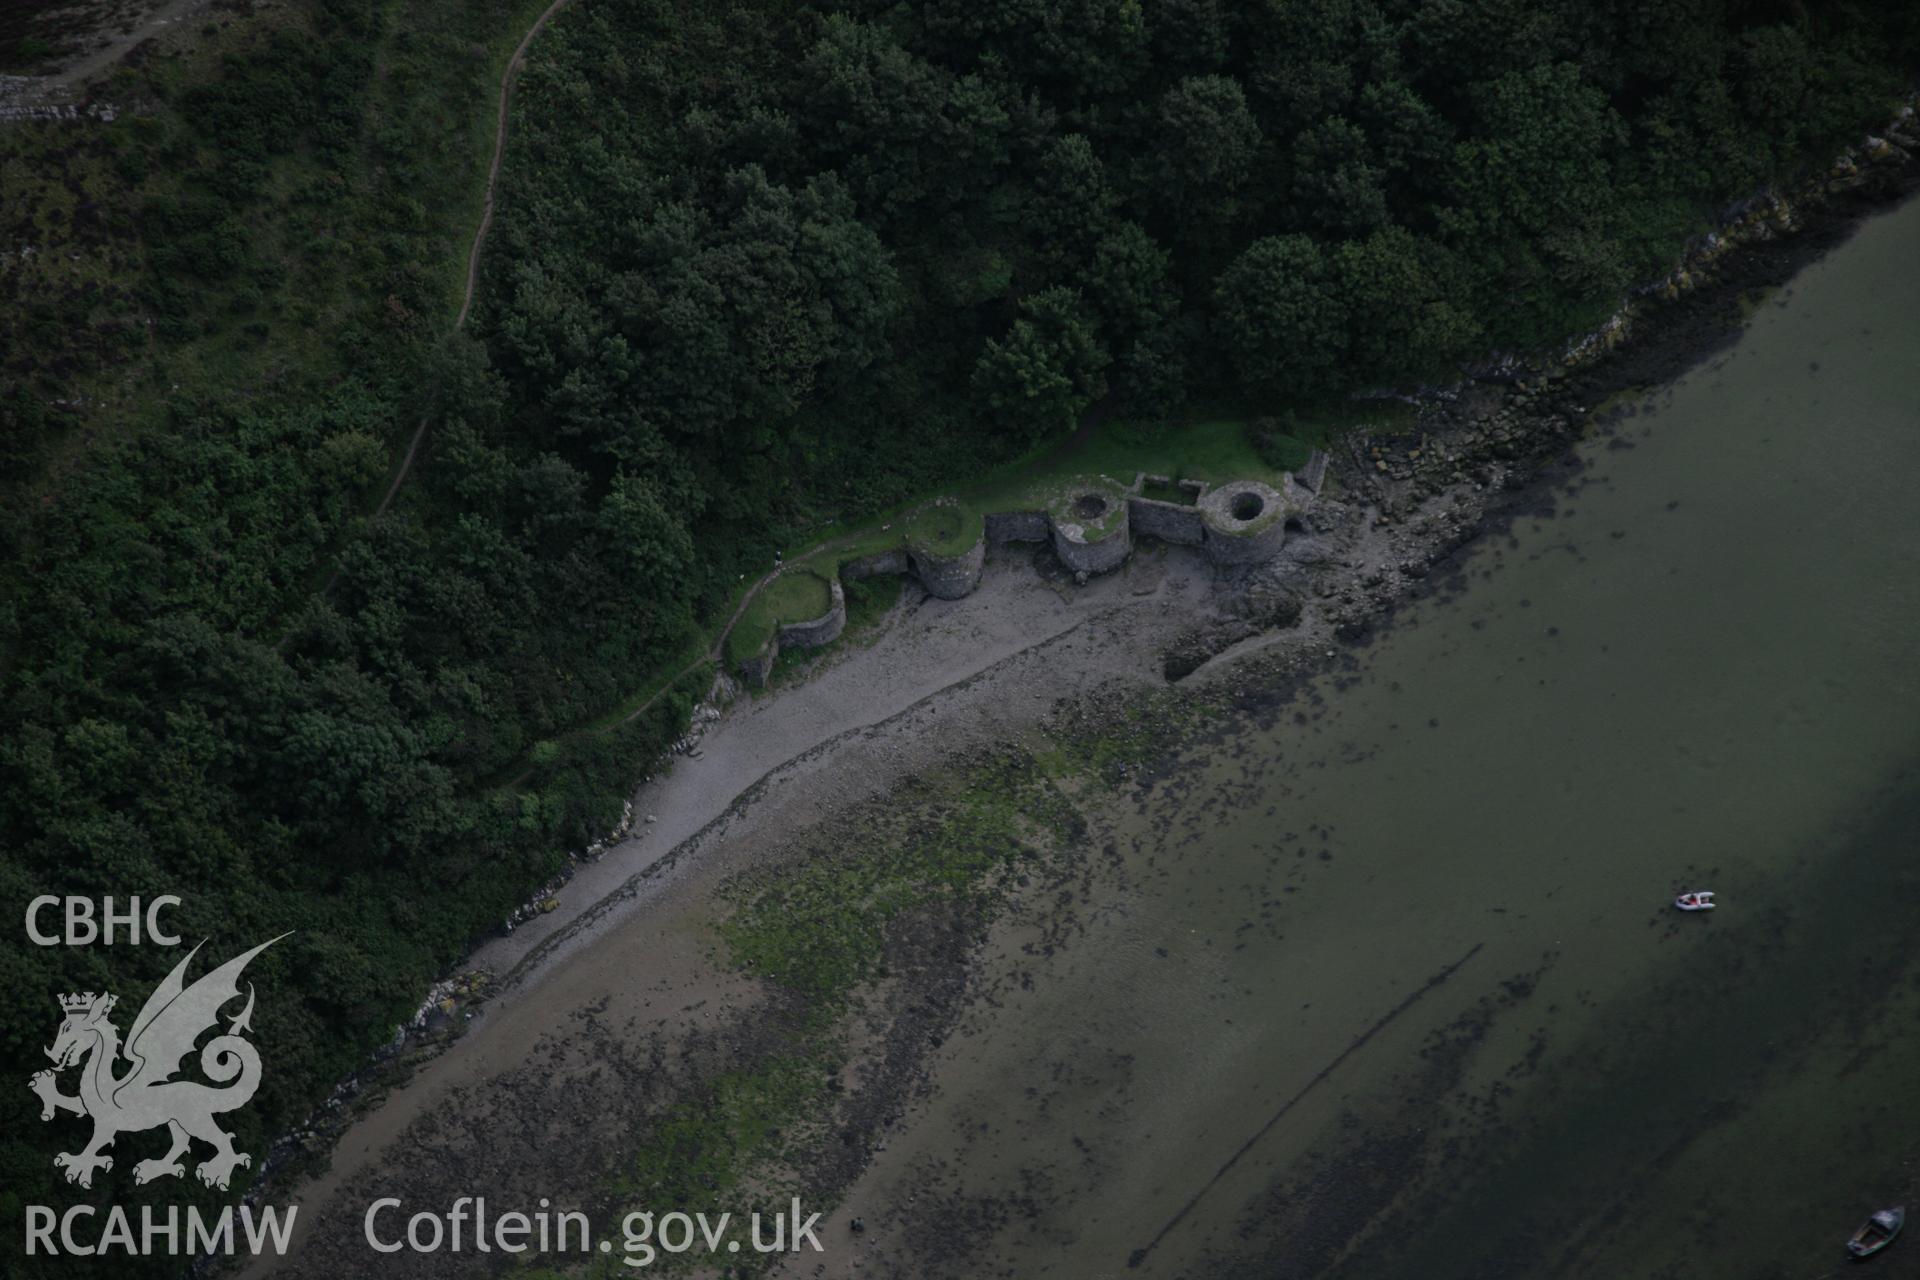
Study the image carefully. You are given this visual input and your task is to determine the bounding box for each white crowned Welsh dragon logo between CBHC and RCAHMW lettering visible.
[29,933,286,1190]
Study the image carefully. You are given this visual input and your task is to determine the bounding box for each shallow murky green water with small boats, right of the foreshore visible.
[867,203,1920,1280]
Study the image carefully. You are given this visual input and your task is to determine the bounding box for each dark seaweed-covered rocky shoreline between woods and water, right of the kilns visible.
[1164,104,1920,681]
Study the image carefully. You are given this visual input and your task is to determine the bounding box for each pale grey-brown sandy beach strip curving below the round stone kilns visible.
[243,549,1212,1274]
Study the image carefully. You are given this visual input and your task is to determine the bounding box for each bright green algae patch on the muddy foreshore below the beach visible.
[552,750,1085,1278]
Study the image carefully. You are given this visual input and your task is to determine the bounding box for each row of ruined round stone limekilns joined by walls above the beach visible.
[739,453,1327,685]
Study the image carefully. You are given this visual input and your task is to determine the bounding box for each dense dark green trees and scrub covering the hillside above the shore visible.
[0,0,1920,1266]
